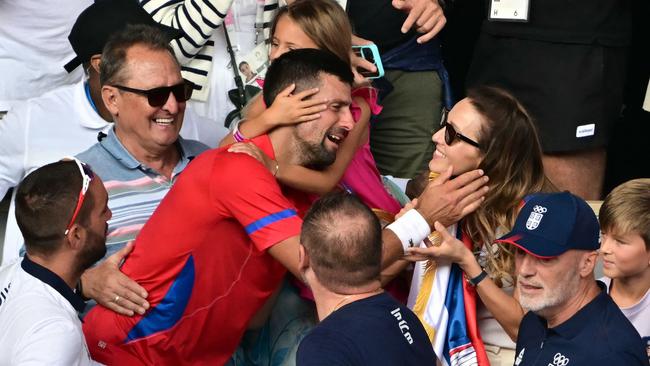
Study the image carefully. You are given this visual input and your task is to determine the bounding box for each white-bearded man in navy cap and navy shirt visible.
[499,192,648,366]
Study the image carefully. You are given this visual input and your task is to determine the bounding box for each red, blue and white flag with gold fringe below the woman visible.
[408,226,490,366]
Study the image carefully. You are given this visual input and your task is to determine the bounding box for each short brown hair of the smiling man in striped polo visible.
[99,24,178,85]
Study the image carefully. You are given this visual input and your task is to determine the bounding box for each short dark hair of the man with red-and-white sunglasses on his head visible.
[16,161,95,255]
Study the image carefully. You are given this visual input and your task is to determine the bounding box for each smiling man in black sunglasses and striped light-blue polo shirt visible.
[77,24,208,315]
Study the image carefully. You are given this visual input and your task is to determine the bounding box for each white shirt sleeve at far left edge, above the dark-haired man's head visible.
[0,102,31,199]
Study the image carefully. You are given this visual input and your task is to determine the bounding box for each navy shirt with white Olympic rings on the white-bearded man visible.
[515,283,648,366]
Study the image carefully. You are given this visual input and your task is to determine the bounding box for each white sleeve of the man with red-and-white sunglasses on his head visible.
[11,318,94,366]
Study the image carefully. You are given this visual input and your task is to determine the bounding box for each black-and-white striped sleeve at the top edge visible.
[141,0,233,65]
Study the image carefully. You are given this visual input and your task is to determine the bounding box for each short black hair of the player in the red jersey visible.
[263,48,354,106]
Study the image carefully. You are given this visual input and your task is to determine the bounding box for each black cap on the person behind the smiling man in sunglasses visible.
[63,0,183,72]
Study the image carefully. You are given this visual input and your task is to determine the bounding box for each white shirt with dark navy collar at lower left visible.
[0,256,96,366]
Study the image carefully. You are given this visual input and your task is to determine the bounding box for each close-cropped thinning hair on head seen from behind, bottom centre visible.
[300,192,382,291]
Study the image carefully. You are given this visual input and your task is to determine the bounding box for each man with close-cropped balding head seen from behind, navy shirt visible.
[296,193,436,366]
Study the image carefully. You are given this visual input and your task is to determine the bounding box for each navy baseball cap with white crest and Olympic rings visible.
[497,192,600,258]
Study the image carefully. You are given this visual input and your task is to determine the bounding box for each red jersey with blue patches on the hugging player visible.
[83,135,309,365]
